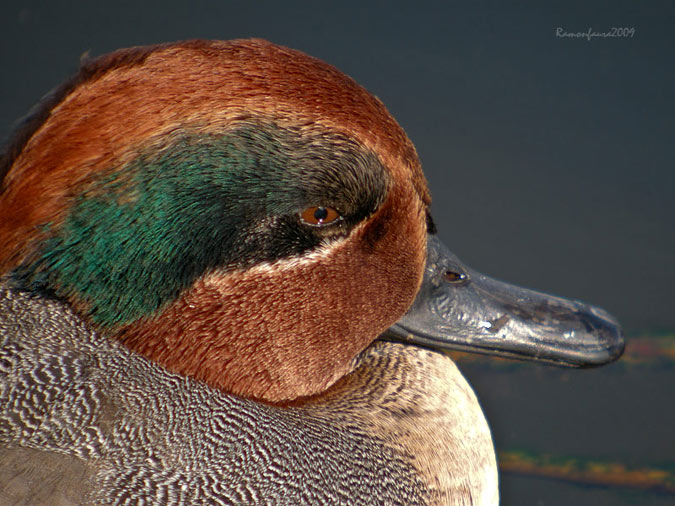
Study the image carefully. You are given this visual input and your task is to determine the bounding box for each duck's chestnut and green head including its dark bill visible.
[0,40,622,402]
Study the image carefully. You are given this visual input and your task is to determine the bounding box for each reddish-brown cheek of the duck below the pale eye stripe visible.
[118,184,426,402]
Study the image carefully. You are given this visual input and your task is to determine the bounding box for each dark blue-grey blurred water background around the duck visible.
[0,0,675,505]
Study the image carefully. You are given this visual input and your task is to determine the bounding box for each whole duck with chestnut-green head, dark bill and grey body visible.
[0,39,623,505]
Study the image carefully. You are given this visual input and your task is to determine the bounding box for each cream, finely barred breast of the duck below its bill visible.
[302,342,498,505]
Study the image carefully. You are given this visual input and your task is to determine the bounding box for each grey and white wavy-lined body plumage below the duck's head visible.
[0,286,429,505]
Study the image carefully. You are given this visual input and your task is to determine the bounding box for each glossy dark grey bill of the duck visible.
[382,236,624,367]
